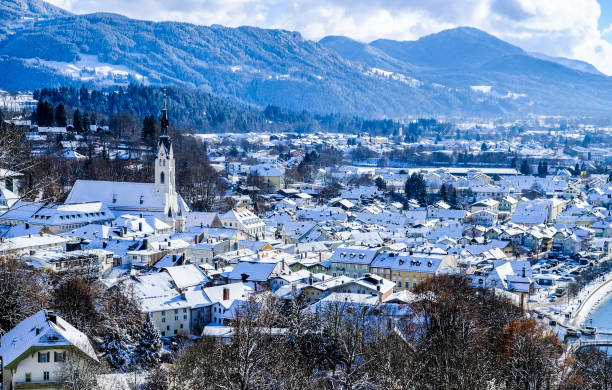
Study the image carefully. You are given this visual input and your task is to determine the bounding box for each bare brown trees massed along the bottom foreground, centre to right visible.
[146,275,612,390]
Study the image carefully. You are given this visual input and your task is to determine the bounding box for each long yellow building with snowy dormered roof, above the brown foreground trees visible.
[370,251,457,291]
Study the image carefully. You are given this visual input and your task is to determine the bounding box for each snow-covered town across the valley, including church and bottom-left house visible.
[0,101,612,389]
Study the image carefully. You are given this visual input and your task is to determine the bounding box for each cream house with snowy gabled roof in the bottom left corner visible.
[0,310,98,390]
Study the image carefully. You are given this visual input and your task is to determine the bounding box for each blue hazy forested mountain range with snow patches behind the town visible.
[0,0,612,119]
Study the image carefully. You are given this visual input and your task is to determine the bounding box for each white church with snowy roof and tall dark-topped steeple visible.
[65,106,189,232]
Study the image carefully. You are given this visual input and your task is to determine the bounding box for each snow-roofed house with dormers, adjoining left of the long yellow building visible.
[329,246,382,278]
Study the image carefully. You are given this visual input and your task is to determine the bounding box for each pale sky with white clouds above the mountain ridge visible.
[47,0,612,75]
